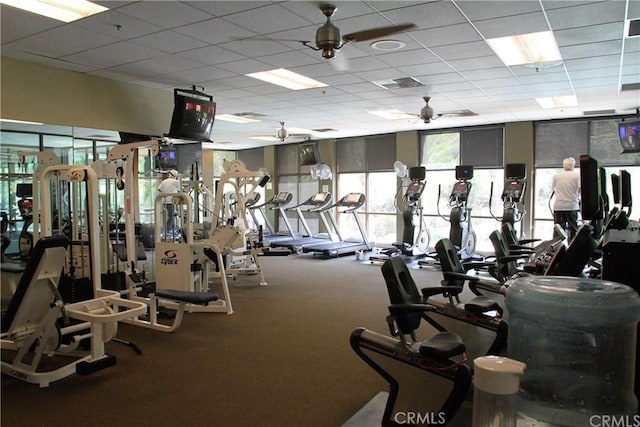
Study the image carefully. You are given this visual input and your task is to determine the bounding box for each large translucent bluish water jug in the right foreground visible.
[506,276,640,427]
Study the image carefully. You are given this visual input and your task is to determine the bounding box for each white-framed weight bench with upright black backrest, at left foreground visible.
[0,236,144,387]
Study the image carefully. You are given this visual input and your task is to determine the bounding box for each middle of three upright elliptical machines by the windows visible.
[436,165,476,260]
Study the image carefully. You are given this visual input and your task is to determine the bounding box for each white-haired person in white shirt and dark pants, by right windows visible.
[553,157,580,241]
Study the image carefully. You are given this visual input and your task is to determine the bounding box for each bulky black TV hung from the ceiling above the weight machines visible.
[169,91,216,141]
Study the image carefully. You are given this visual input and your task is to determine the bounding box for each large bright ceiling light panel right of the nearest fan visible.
[487,31,562,66]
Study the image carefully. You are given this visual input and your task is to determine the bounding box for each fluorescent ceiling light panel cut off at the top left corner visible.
[0,0,108,22]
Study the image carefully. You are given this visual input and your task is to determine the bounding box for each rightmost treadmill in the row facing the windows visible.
[302,193,373,258]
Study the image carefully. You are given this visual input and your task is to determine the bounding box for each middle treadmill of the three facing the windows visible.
[269,192,334,252]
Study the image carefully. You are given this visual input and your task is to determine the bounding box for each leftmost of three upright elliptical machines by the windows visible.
[369,166,431,262]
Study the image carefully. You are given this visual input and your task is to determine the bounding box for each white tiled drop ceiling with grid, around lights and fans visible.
[0,0,640,149]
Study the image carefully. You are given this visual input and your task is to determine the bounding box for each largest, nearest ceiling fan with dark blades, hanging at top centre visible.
[238,3,416,59]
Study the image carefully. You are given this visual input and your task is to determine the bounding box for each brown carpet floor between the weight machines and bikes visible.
[0,255,440,427]
